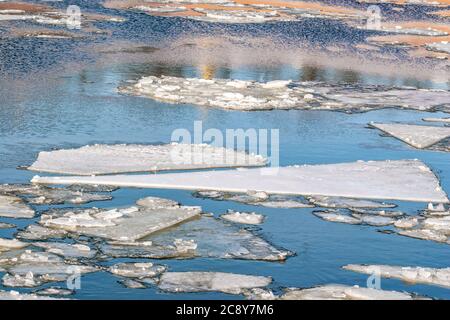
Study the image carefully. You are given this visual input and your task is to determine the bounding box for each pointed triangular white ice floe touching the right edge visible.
[370,123,450,149]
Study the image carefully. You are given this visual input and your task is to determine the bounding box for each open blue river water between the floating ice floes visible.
[0,0,450,299]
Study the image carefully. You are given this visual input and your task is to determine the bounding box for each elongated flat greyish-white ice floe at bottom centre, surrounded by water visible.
[158,272,272,294]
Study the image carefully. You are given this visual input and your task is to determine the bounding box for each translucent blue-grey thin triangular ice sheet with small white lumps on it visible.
[100,215,292,261]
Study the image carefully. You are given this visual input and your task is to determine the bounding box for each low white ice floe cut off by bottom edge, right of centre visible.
[279,284,422,300]
